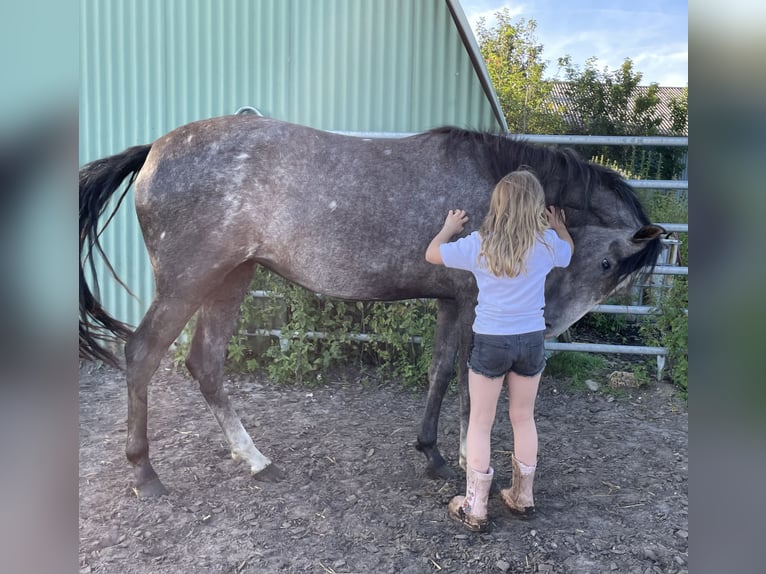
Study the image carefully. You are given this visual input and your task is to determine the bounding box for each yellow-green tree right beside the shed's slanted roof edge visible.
[477,8,564,134]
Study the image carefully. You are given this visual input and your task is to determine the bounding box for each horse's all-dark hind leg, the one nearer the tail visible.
[125,298,197,496]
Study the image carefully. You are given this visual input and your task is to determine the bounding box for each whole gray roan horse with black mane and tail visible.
[79,116,663,495]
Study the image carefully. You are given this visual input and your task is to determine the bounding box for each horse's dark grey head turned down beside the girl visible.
[545,220,664,337]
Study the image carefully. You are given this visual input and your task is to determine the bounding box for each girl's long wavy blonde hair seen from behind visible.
[479,169,549,277]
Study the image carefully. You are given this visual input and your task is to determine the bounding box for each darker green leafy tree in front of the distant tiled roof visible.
[559,56,688,179]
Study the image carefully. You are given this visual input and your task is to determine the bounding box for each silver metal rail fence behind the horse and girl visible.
[247,131,689,379]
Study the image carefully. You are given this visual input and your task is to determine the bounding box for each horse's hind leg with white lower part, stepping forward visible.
[186,262,283,481]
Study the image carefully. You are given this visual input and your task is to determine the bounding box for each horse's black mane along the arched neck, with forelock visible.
[428,126,662,278]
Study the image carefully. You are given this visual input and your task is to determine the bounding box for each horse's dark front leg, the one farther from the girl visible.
[415,299,461,478]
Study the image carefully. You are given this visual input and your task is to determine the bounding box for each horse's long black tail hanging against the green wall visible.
[80,144,152,367]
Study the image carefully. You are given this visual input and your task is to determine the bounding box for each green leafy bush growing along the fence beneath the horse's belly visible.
[176,268,436,387]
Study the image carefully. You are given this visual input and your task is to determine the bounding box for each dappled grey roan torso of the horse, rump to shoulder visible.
[136,116,486,299]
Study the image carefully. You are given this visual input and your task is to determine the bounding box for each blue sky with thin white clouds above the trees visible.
[460,0,689,87]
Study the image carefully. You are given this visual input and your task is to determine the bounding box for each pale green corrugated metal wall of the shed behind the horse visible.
[80,0,501,324]
